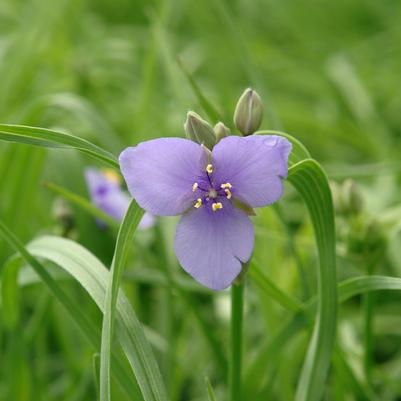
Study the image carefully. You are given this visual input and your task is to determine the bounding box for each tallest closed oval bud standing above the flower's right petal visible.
[234,88,263,136]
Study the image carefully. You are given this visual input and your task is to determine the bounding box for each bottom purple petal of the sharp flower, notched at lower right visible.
[175,202,254,290]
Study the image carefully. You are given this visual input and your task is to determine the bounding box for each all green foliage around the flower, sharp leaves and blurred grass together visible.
[0,0,401,401]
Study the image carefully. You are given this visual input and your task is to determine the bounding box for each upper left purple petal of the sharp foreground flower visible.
[120,138,207,216]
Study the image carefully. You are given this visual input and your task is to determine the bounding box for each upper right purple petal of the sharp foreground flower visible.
[212,135,291,207]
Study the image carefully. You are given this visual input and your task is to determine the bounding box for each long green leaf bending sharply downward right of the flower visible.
[288,159,337,401]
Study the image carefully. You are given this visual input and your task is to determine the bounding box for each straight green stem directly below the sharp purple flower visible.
[228,281,244,401]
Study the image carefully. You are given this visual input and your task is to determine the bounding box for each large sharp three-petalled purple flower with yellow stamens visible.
[120,135,291,290]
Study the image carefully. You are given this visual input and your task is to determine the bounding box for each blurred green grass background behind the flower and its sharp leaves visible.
[0,0,401,401]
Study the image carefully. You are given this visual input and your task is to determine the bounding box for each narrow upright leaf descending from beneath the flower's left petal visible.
[100,200,145,401]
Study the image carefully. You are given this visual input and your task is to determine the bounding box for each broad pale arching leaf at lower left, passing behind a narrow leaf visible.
[24,236,167,401]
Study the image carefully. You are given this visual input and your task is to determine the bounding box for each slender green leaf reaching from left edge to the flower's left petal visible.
[0,124,119,169]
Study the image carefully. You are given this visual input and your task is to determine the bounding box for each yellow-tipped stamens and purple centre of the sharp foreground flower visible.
[192,164,232,212]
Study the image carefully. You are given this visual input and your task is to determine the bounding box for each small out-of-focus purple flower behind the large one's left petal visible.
[85,168,155,229]
